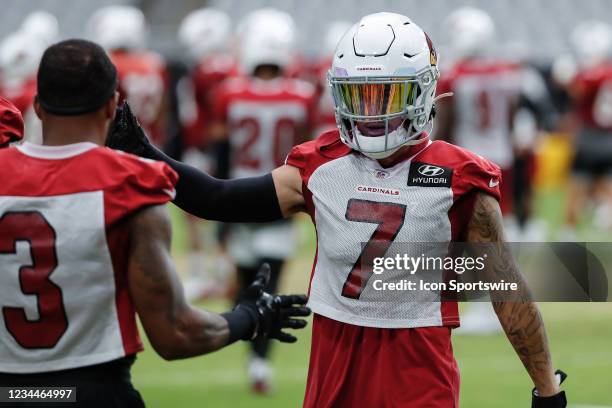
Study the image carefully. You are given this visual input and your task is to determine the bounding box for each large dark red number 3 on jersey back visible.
[0,211,68,349]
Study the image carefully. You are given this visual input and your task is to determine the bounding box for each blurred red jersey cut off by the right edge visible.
[572,62,612,131]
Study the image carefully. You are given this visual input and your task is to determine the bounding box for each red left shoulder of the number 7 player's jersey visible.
[285,129,351,180]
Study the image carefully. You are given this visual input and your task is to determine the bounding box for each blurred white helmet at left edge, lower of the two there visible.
[0,31,46,85]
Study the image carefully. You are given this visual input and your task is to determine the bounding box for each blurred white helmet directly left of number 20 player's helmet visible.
[178,8,232,61]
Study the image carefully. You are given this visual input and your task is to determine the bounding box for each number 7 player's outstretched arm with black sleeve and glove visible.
[107,103,303,222]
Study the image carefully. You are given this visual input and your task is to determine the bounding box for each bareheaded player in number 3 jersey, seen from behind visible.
[0,40,309,408]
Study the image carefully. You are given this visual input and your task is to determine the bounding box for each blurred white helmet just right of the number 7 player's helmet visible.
[443,7,495,58]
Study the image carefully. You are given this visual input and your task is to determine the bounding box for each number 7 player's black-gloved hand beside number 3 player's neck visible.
[106,102,151,157]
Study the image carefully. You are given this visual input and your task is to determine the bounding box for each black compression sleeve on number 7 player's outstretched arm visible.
[145,145,283,222]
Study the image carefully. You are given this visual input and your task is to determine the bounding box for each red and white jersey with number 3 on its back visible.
[0,142,177,373]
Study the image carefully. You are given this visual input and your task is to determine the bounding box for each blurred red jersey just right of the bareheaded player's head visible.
[110,51,168,145]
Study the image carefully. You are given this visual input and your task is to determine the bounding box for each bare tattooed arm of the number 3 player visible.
[128,206,229,359]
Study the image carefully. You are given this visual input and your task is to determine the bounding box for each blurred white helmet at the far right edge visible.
[570,20,612,66]
